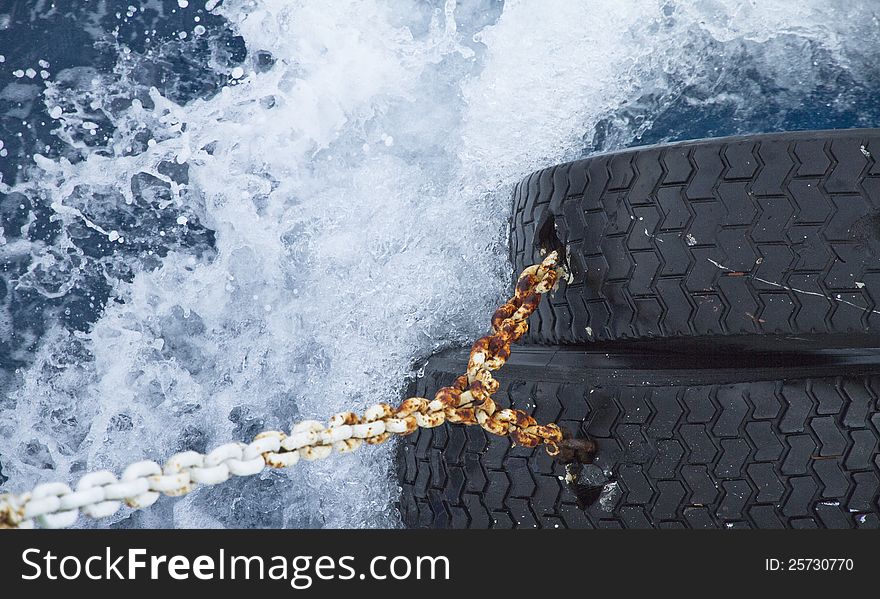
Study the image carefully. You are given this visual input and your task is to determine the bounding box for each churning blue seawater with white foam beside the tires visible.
[0,0,880,527]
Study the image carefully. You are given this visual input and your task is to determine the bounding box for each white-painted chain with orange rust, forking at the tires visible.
[0,252,592,528]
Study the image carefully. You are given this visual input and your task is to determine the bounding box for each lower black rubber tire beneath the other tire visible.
[398,347,880,528]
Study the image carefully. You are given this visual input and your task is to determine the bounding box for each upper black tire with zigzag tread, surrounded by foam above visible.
[511,129,880,350]
